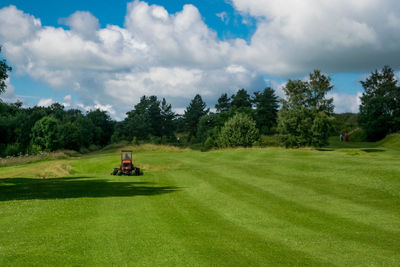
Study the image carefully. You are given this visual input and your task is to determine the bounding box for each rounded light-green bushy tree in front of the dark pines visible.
[217,113,259,147]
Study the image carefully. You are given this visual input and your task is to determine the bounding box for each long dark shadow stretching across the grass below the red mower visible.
[0,177,179,201]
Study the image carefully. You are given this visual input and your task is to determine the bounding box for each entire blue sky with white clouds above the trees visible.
[0,0,400,120]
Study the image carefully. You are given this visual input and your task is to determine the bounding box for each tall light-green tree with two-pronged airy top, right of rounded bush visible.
[278,70,334,147]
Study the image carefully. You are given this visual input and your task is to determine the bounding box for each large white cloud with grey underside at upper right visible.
[232,0,400,76]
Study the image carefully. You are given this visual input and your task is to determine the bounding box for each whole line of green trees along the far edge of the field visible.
[0,44,400,157]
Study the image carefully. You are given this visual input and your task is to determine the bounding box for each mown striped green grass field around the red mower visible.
[0,139,400,266]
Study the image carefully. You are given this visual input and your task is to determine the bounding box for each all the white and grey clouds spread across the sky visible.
[0,0,400,117]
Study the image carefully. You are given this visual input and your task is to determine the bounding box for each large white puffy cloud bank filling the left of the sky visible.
[0,1,265,117]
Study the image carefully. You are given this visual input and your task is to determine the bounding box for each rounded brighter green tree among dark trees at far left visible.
[32,116,62,151]
